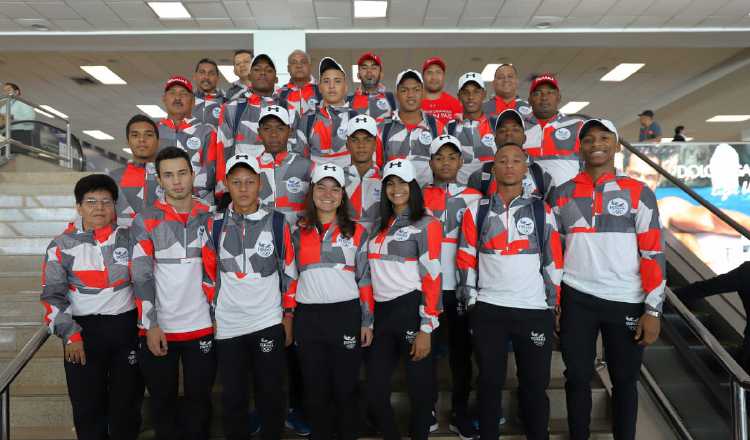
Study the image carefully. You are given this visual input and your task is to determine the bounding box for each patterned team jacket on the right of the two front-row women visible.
[367,209,443,333]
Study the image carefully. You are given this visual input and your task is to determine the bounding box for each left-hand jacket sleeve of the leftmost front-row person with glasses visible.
[40,240,82,344]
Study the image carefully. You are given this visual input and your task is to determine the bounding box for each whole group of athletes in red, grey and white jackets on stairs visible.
[41,50,665,440]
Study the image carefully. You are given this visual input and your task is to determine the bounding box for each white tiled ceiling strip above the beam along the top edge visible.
[0,0,750,32]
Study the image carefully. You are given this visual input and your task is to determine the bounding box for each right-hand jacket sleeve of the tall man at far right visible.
[635,186,666,312]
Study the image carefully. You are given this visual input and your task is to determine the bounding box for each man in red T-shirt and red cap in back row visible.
[422,57,463,124]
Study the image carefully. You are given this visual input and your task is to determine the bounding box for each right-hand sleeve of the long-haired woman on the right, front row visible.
[417,217,443,333]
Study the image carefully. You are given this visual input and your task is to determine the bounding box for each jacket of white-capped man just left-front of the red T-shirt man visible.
[377,112,443,186]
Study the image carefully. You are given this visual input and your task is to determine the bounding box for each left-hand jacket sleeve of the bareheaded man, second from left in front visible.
[130,215,159,330]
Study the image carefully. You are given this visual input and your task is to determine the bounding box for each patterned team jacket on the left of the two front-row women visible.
[292,223,375,327]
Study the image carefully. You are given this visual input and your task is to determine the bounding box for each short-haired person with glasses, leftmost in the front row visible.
[41,174,143,440]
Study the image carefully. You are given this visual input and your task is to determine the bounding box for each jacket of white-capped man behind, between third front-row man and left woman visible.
[258,151,315,225]
